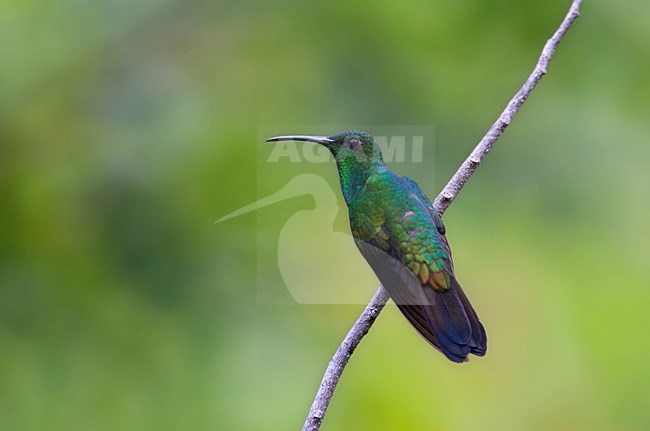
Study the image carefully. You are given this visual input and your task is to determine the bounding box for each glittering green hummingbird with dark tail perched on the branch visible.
[267,131,487,362]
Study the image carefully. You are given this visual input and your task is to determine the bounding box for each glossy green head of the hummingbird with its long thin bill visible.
[266,130,383,165]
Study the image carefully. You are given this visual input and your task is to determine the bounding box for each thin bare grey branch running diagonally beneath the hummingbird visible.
[302,0,582,431]
